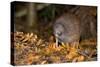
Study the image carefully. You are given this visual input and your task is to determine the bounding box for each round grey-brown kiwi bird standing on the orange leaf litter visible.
[53,14,80,46]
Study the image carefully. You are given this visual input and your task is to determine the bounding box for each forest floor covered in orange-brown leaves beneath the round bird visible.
[11,32,97,65]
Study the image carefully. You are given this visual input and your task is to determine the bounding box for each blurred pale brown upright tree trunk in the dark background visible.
[27,3,37,28]
